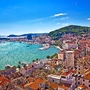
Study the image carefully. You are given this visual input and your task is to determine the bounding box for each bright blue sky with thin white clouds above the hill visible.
[0,0,90,35]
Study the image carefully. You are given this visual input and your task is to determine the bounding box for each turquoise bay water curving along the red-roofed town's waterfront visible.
[0,42,59,70]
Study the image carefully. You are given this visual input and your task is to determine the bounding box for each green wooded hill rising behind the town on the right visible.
[48,25,90,40]
